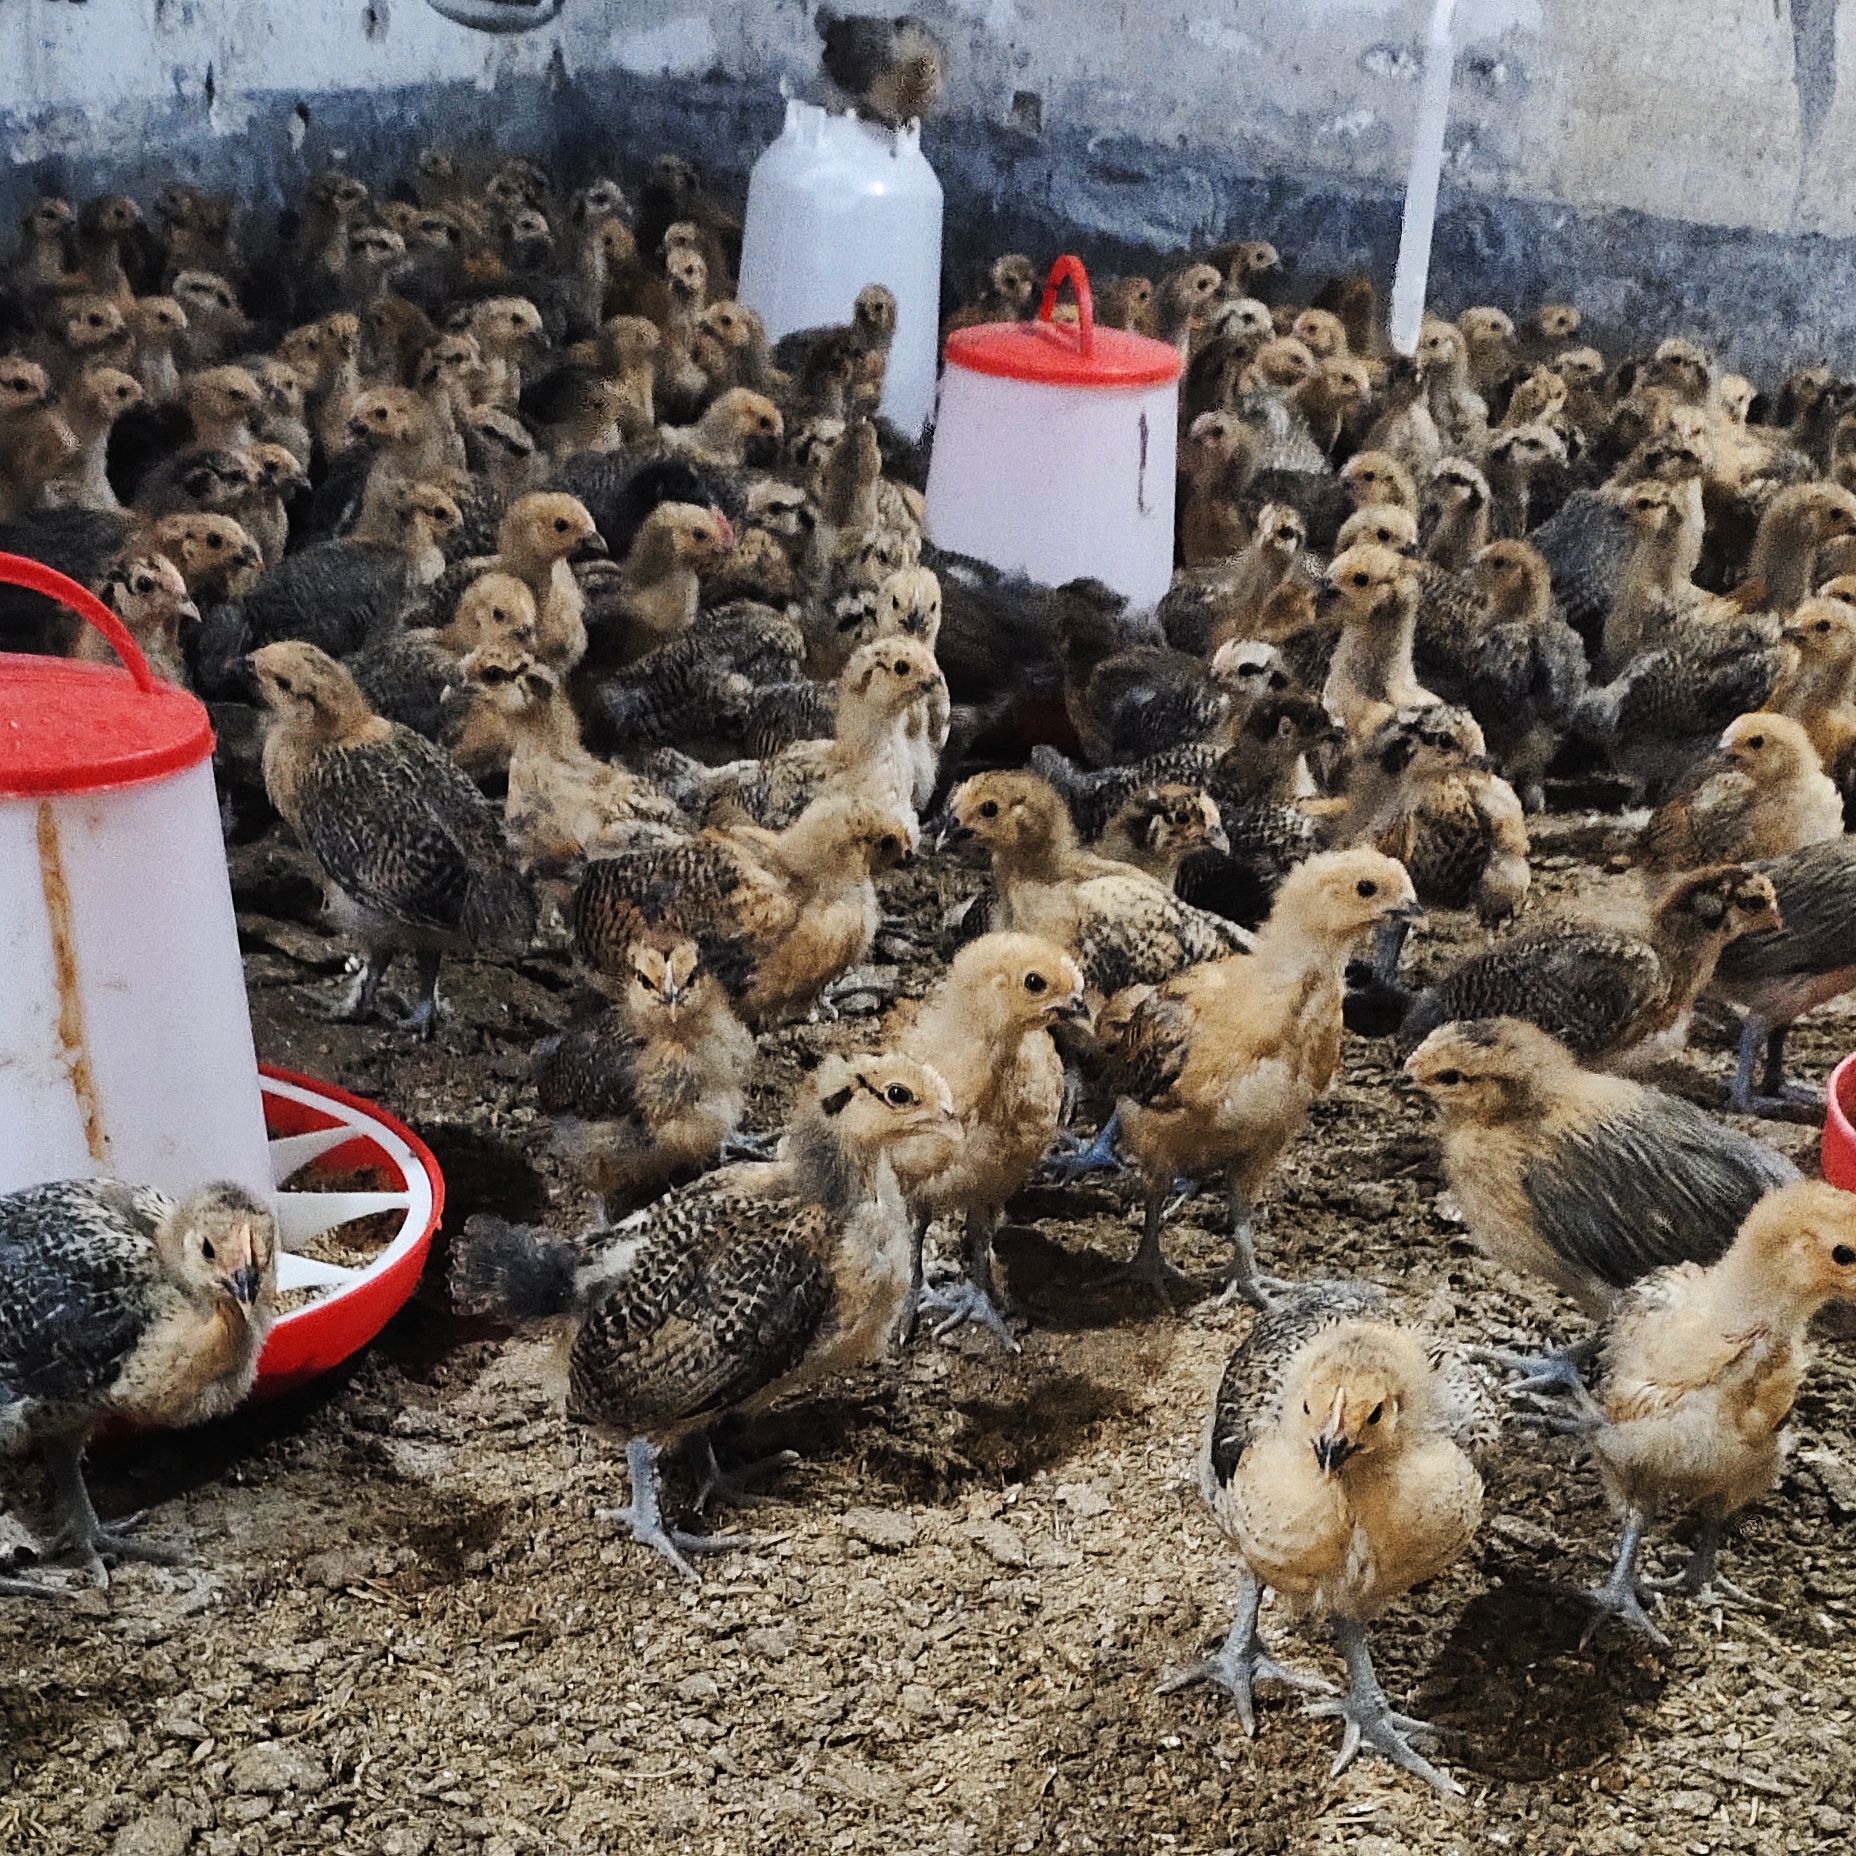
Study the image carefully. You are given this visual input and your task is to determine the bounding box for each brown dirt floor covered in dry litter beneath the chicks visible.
[0,820,1856,1856]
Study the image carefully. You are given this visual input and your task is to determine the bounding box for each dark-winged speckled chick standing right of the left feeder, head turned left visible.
[251,642,535,1038]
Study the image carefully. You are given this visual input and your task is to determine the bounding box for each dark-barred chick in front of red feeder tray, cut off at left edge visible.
[0,1179,277,1594]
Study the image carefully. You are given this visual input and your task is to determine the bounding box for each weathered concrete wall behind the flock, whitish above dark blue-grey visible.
[0,0,1856,360]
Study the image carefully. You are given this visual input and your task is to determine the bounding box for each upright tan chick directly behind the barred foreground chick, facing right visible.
[885,934,1088,1353]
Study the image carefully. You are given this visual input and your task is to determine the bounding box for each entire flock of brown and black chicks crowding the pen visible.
[0,20,1856,1791]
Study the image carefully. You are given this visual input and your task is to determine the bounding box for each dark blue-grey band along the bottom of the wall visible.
[0,61,1856,377]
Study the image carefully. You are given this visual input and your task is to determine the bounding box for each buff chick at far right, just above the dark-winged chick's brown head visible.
[1639,711,1843,896]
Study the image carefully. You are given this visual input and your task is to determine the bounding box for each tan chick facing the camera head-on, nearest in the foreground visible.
[1166,1282,1494,1797]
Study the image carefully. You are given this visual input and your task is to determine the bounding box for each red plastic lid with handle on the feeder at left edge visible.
[0,553,213,798]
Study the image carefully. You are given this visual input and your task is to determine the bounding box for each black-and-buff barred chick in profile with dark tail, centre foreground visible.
[451,1056,961,1578]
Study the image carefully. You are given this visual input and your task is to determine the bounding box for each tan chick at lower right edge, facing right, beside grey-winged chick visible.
[1589,1180,1856,1648]
